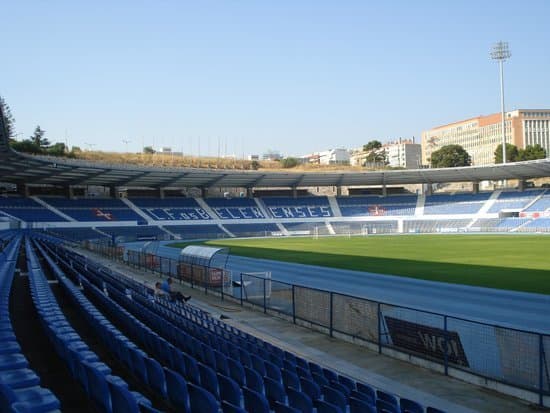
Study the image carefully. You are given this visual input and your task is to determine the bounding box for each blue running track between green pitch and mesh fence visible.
[127,243,550,334]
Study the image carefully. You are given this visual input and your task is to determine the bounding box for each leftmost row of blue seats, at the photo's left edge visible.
[0,236,60,413]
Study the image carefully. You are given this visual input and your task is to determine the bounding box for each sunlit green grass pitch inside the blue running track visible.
[172,234,550,294]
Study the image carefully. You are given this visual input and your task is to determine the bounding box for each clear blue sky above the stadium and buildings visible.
[0,0,550,156]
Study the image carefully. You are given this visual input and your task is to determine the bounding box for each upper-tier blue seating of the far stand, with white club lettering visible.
[0,190,550,222]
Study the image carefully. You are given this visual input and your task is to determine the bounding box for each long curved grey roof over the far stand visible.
[0,108,550,188]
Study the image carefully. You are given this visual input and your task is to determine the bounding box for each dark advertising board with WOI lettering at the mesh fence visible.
[384,316,469,367]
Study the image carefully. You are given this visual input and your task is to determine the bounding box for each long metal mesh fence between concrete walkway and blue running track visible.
[83,241,550,406]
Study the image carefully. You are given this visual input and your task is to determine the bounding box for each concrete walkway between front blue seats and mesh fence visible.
[78,250,544,413]
